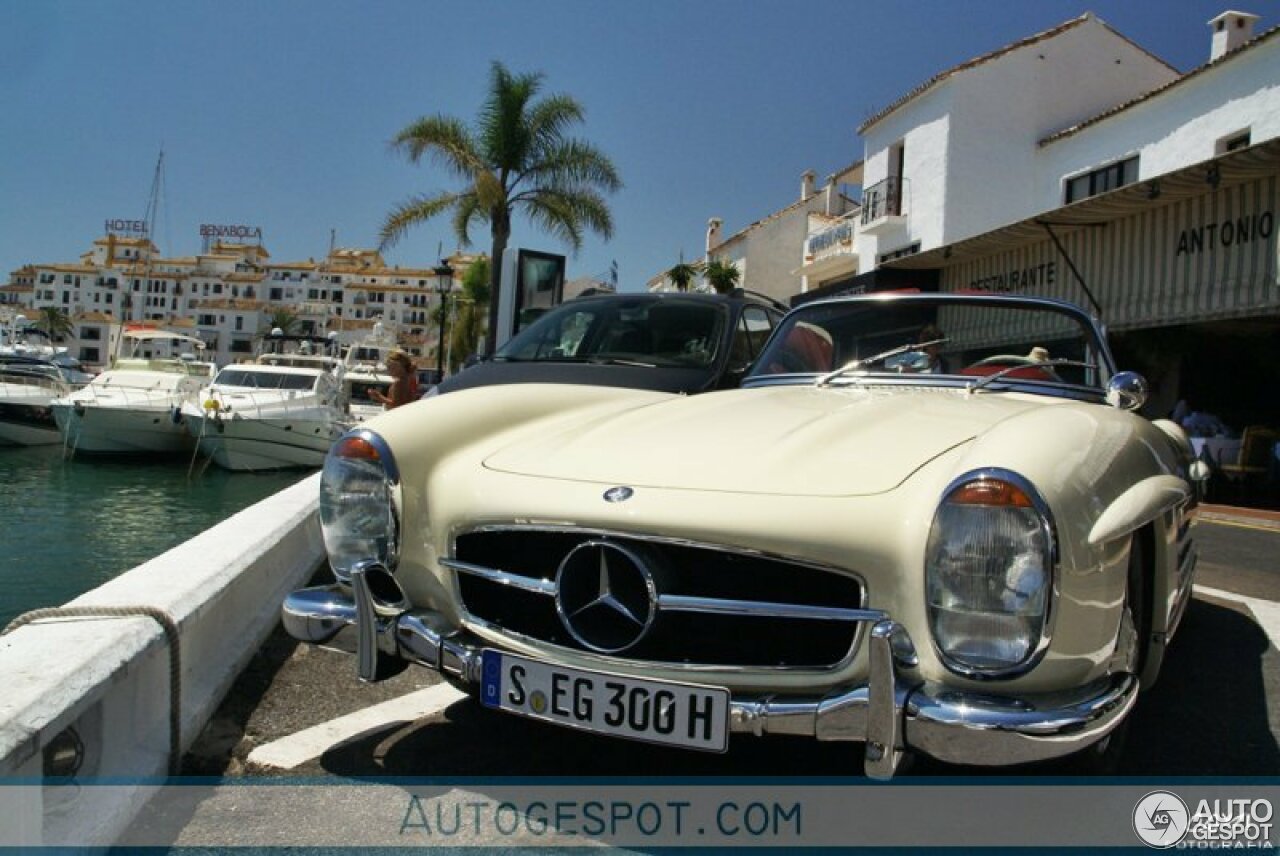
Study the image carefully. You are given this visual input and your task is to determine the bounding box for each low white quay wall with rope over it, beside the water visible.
[0,473,324,847]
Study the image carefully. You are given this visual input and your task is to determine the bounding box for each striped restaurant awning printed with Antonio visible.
[887,141,1280,330]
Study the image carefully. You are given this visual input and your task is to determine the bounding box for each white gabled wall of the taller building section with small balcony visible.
[859,17,1178,273]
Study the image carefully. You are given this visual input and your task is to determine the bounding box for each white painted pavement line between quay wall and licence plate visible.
[248,683,466,770]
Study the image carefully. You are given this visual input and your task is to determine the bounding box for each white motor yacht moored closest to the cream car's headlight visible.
[182,334,349,471]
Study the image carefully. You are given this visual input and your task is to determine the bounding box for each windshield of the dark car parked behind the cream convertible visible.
[494,296,727,369]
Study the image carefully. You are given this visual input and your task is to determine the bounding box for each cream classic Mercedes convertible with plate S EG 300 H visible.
[283,294,1204,778]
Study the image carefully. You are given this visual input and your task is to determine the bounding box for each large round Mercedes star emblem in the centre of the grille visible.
[556,541,658,654]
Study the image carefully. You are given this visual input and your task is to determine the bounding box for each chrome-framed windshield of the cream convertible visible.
[748,294,1112,389]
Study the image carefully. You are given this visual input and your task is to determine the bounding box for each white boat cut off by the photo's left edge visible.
[0,353,90,445]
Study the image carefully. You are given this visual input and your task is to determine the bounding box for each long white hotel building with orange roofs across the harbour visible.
[0,234,475,367]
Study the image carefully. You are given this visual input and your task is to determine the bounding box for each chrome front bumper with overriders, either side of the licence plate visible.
[282,564,1138,779]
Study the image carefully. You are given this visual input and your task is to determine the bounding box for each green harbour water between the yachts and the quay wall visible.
[0,445,312,630]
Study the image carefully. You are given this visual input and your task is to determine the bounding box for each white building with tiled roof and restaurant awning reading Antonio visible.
[675,12,1280,427]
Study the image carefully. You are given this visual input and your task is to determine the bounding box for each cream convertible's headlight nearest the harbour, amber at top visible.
[320,429,401,582]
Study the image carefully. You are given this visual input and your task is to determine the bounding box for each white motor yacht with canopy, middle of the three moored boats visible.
[50,330,215,454]
